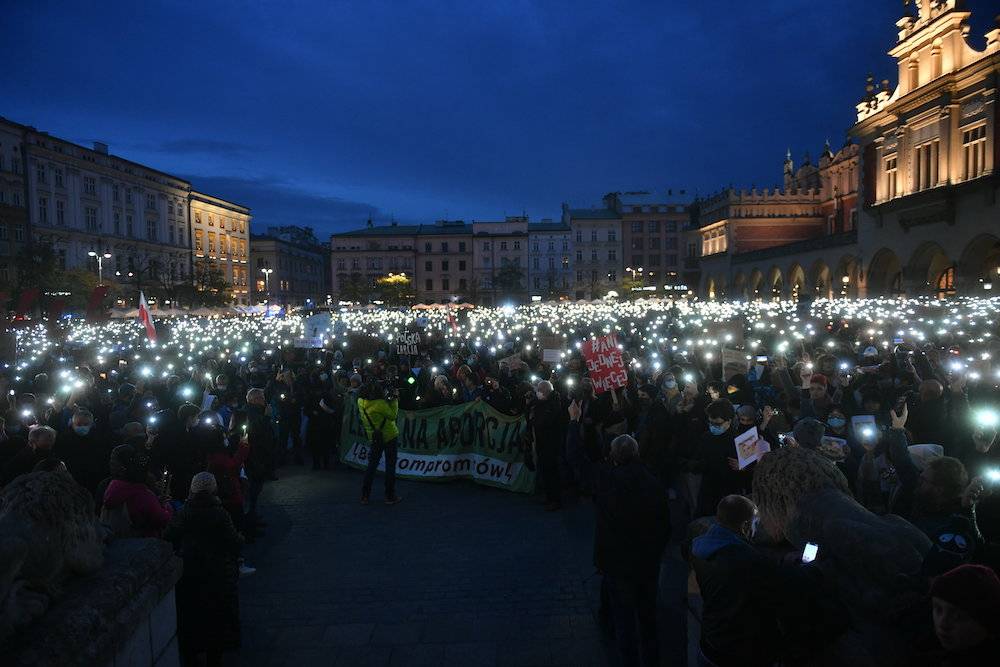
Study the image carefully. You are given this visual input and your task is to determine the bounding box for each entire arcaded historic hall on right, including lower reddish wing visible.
[689,0,1000,299]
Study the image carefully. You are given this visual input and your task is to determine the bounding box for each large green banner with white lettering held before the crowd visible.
[340,399,535,493]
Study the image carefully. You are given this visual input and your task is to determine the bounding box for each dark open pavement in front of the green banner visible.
[239,467,686,667]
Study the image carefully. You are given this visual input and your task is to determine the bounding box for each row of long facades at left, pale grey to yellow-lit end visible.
[0,118,250,302]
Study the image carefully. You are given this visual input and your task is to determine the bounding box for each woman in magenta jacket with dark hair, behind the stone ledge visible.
[102,445,173,537]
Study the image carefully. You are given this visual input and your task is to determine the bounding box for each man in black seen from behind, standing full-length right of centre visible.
[594,435,670,666]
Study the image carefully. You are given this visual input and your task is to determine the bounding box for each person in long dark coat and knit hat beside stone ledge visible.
[164,472,243,665]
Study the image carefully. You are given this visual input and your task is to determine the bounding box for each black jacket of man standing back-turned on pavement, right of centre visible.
[594,461,670,579]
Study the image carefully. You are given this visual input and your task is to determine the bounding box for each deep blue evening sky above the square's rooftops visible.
[0,0,997,235]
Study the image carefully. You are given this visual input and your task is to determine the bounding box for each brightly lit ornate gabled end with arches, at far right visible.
[851,0,1000,295]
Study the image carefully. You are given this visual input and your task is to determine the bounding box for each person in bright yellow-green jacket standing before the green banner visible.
[358,382,402,505]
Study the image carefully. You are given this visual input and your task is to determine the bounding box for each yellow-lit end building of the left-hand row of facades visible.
[189,192,250,305]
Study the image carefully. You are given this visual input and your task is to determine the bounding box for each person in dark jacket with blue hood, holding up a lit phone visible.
[691,495,785,667]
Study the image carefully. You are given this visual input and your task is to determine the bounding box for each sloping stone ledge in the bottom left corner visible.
[0,539,181,667]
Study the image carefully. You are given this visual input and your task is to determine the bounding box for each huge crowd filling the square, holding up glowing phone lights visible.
[0,300,1000,667]
